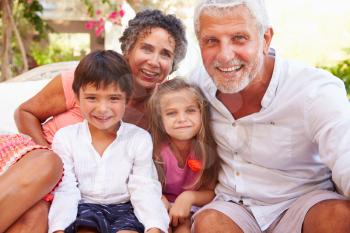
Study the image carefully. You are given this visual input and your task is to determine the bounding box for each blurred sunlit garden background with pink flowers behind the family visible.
[0,0,350,91]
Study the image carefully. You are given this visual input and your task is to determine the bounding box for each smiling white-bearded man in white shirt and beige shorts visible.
[191,0,350,233]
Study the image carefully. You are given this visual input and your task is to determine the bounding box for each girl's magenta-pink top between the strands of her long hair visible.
[161,145,199,202]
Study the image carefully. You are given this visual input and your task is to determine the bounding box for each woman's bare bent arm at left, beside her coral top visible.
[14,75,67,146]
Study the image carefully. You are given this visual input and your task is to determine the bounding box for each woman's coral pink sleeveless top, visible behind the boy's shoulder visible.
[43,70,83,144]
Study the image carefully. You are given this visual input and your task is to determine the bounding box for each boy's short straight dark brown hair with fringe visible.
[72,50,133,99]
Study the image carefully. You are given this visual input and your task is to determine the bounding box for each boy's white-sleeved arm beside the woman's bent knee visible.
[49,129,81,232]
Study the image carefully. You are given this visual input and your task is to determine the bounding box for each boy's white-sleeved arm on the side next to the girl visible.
[128,132,169,232]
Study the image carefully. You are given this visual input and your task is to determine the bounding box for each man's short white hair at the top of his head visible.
[194,0,269,38]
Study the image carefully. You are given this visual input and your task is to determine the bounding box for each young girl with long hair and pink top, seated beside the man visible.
[149,78,219,233]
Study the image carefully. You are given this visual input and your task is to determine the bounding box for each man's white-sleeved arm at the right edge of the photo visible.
[304,77,350,197]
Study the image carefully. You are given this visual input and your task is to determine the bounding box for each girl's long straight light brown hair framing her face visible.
[148,78,220,189]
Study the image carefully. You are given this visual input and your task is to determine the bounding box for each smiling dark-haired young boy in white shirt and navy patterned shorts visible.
[49,51,169,233]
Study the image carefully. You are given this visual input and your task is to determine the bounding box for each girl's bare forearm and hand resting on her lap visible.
[169,190,215,227]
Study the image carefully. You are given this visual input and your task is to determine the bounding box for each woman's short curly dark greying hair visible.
[119,9,187,72]
